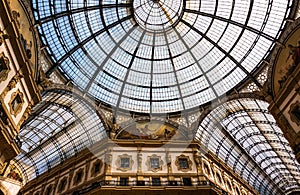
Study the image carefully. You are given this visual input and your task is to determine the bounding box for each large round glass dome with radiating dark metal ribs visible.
[32,0,292,113]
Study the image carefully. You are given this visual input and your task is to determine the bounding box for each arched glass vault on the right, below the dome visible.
[196,98,300,195]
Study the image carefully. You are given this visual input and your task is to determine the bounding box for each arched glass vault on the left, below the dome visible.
[14,89,106,182]
